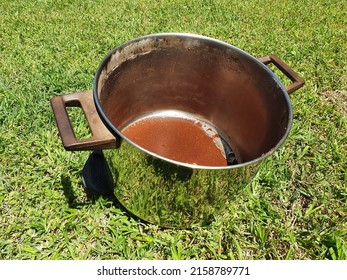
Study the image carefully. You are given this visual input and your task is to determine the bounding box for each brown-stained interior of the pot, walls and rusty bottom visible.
[95,35,291,166]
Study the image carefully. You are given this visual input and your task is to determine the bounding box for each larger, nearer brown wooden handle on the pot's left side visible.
[51,90,116,151]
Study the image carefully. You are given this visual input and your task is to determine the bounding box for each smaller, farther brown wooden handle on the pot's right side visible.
[259,54,305,93]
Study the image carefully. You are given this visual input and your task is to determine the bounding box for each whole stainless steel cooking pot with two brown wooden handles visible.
[51,33,304,228]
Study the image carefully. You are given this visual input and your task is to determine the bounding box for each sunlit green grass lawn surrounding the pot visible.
[0,0,347,259]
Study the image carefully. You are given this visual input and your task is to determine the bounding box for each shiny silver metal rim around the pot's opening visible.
[93,32,293,170]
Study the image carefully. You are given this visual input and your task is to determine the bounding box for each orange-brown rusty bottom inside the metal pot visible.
[122,116,227,166]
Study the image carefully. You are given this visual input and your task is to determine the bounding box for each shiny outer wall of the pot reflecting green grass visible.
[104,141,259,228]
